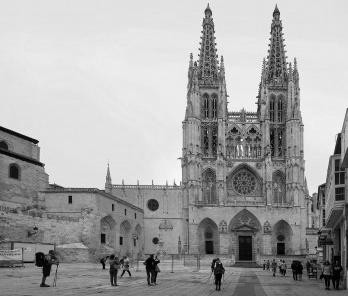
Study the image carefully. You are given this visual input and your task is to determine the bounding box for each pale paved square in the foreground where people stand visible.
[0,264,347,296]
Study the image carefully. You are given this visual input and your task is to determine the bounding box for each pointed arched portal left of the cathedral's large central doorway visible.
[197,218,219,254]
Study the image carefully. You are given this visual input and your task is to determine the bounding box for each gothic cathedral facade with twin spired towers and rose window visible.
[182,5,308,261]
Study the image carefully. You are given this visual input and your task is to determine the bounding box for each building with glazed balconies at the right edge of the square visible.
[318,109,348,287]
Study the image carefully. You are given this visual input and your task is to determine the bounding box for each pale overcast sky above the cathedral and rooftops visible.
[0,0,348,193]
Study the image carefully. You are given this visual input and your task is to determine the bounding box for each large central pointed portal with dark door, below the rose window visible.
[229,209,261,261]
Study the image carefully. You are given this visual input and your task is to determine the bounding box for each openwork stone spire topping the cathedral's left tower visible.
[198,4,218,85]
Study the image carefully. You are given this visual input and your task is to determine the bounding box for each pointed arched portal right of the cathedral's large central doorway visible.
[271,220,293,255]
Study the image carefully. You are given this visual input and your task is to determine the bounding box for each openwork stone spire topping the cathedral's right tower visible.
[267,5,287,84]
